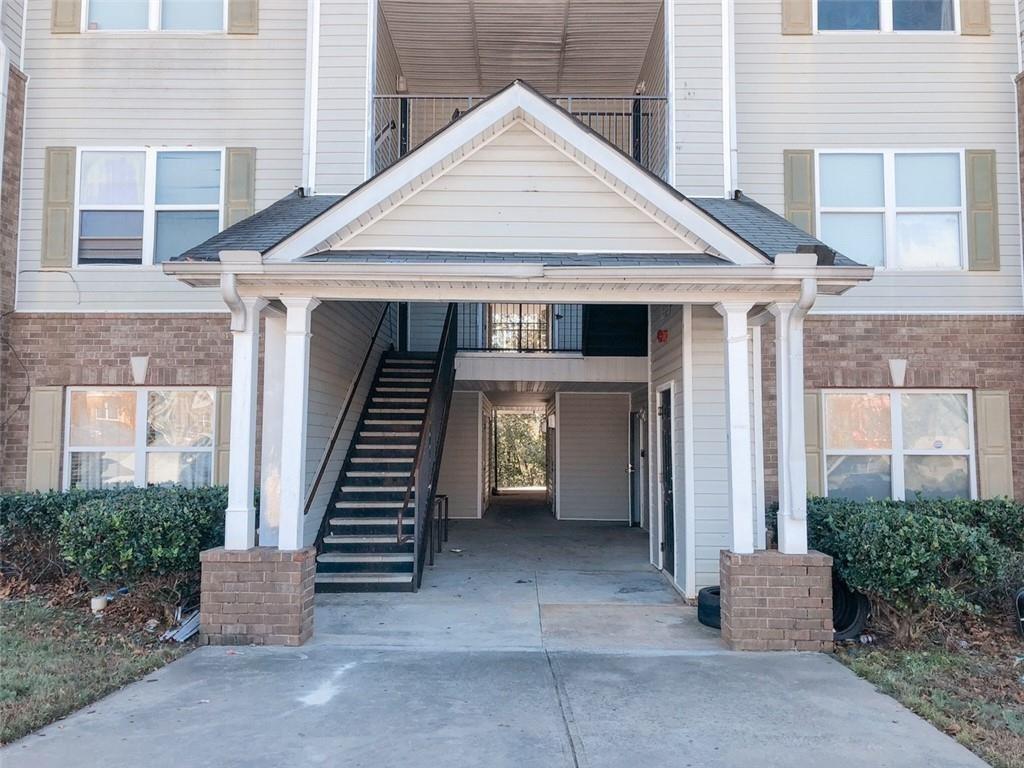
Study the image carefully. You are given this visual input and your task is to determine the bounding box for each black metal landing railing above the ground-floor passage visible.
[458,302,583,352]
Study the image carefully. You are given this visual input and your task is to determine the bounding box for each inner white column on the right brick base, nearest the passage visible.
[715,302,754,554]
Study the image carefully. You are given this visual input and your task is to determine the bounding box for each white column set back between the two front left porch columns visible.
[259,311,285,547]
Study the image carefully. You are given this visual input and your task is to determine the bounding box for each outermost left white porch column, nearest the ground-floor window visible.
[224,298,266,550]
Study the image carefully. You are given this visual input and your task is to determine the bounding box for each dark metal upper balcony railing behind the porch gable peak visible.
[374,95,669,178]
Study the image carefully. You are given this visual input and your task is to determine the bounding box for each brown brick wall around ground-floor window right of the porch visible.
[762,314,1024,501]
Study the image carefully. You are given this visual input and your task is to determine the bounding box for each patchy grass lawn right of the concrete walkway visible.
[837,634,1024,768]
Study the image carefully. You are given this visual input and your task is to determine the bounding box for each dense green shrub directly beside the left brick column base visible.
[58,486,227,585]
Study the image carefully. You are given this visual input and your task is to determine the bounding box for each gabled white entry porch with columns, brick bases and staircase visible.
[164,82,872,647]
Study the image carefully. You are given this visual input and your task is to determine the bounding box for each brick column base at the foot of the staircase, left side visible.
[200,547,316,645]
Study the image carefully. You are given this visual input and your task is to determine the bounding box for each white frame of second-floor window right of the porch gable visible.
[814,147,968,274]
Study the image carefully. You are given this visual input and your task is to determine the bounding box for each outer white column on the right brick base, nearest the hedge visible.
[769,302,807,555]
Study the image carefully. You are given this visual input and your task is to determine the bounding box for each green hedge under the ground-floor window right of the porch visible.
[786,499,1024,640]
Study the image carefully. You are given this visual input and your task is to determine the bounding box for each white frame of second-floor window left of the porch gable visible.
[72,146,226,270]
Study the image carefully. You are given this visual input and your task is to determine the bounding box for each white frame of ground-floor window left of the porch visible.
[61,386,218,490]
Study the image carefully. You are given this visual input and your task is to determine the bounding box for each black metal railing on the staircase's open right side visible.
[395,303,459,589]
